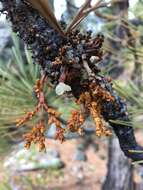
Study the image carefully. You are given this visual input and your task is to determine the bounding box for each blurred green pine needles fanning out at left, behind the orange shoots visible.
[0,34,75,151]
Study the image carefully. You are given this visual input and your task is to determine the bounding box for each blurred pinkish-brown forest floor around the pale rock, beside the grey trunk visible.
[0,132,141,190]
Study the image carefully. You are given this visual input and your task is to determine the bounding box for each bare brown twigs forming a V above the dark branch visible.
[28,0,109,36]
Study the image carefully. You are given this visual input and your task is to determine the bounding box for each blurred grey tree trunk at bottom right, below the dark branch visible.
[102,138,135,190]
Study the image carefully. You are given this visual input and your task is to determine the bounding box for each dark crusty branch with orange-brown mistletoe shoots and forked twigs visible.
[0,0,143,161]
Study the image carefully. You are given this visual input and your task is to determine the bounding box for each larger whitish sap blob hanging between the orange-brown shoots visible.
[55,82,71,96]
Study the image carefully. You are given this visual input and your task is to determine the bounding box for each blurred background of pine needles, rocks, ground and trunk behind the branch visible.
[0,0,143,190]
